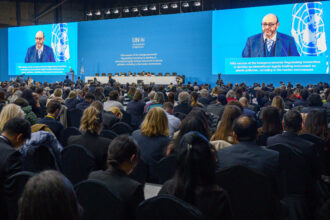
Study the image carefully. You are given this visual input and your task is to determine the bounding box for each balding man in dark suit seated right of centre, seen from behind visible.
[218,115,279,180]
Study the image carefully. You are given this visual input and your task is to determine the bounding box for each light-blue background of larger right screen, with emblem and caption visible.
[212,2,330,85]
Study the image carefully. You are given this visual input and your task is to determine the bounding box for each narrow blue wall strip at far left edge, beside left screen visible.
[0,28,9,81]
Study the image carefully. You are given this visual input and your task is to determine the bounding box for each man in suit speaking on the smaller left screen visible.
[25,31,56,63]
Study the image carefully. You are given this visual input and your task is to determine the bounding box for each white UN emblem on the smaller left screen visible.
[52,23,70,62]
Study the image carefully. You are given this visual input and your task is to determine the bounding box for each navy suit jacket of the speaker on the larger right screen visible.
[242,32,300,57]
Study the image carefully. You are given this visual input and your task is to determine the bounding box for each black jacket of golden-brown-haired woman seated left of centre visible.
[68,132,112,170]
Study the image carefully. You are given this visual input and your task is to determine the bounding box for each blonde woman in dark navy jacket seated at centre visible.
[132,107,170,182]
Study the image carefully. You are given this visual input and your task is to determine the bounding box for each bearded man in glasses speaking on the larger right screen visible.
[242,14,300,57]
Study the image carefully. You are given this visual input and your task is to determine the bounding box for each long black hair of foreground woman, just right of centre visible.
[173,131,216,203]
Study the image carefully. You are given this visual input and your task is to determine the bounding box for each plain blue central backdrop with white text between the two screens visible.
[78,12,212,83]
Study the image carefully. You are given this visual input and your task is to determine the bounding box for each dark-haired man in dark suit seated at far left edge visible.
[0,118,31,219]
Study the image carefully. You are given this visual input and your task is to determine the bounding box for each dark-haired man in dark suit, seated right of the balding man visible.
[267,110,320,179]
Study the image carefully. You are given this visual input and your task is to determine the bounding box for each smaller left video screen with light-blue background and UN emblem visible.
[8,23,78,81]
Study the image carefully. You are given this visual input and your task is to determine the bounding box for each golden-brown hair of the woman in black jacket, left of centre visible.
[79,106,102,133]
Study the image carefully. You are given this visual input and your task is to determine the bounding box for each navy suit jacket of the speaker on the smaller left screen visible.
[25,45,56,63]
